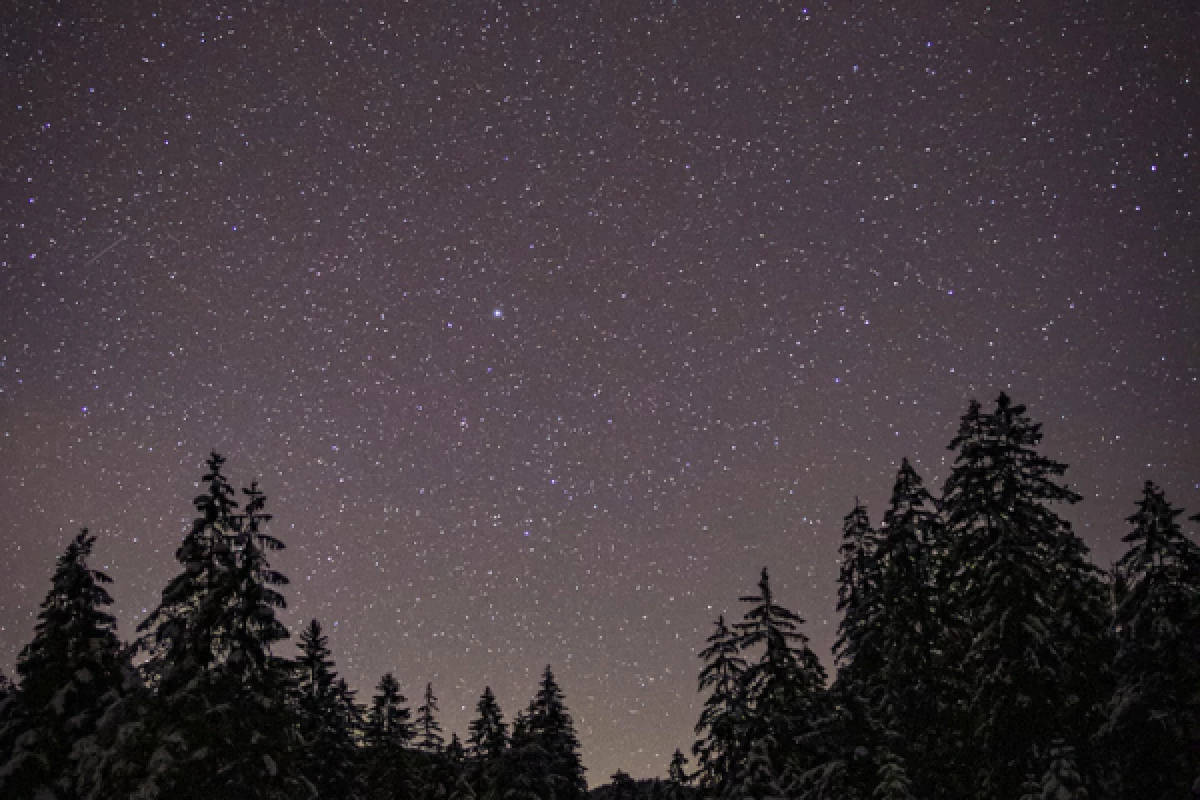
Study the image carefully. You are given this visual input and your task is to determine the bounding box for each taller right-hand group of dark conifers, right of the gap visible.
[692,395,1200,800]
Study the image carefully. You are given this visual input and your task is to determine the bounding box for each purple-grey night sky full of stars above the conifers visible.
[0,0,1200,784]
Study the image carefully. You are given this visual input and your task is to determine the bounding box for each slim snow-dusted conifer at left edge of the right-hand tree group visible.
[691,614,749,795]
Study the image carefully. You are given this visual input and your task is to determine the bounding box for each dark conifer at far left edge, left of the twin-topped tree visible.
[0,529,128,800]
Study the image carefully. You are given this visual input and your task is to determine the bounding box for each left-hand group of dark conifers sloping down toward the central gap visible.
[0,453,587,800]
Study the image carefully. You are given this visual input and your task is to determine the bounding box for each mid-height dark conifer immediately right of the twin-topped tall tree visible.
[295,620,361,800]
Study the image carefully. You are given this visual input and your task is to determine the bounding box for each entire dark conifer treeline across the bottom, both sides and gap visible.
[0,395,1200,800]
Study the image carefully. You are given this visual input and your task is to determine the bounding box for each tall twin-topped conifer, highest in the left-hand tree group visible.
[127,453,306,800]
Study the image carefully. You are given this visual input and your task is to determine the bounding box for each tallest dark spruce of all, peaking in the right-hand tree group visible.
[943,393,1103,800]
